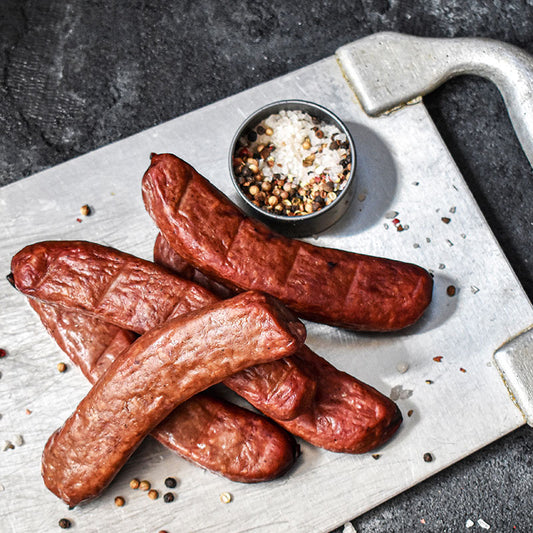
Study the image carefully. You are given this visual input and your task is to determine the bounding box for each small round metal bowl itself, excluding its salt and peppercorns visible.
[229,100,356,237]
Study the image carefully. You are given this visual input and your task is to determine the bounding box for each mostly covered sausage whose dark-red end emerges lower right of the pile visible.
[154,234,402,453]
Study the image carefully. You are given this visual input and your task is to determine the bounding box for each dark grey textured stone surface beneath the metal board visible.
[0,0,533,533]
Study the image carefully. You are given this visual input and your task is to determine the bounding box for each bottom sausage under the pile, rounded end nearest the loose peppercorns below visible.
[29,298,299,483]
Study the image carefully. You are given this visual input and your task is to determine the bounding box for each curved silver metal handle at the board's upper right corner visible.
[336,32,533,166]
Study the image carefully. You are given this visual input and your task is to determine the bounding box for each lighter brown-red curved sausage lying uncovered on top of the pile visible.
[42,292,305,506]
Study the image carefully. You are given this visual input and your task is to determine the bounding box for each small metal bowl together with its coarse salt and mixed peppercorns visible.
[230,100,356,237]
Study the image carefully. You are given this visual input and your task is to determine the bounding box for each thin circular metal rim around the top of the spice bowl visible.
[229,99,357,224]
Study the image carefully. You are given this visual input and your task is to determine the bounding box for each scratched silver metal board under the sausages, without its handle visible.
[0,58,533,532]
